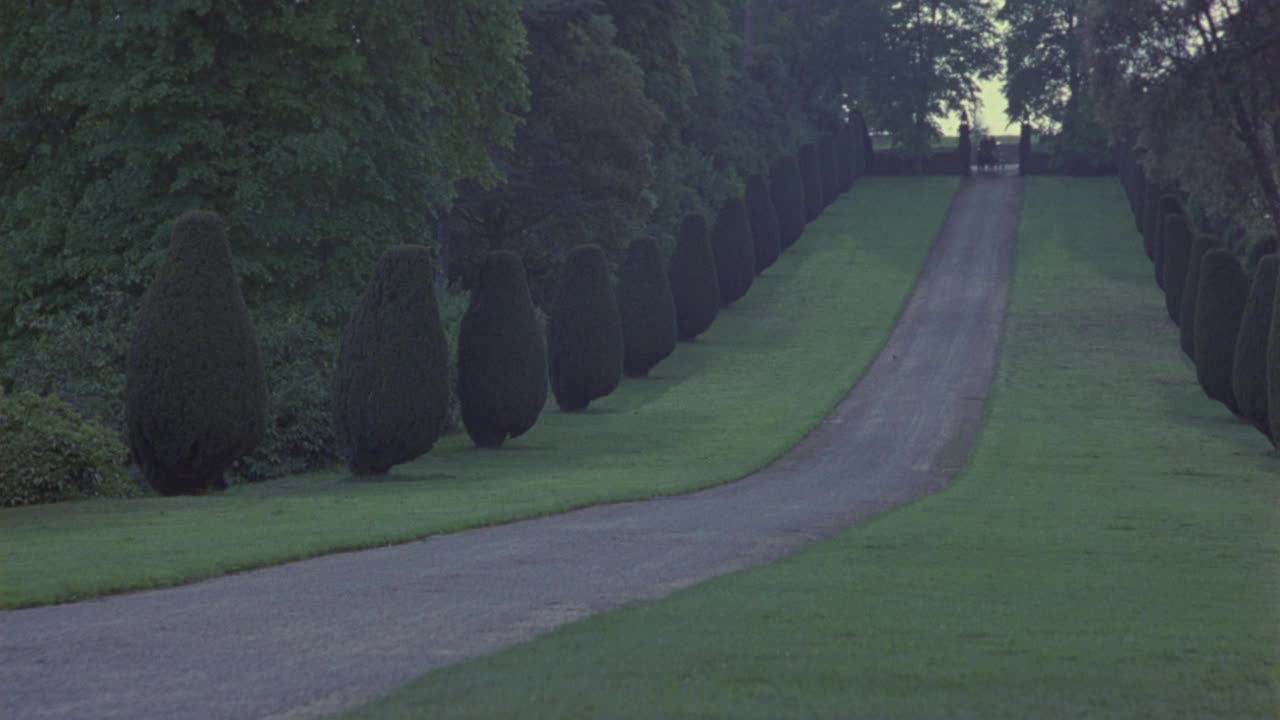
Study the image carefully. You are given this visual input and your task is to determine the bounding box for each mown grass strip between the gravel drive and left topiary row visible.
[0,178,956,607]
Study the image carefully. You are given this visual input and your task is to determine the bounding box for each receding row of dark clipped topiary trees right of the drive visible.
[1117,147,1280,446]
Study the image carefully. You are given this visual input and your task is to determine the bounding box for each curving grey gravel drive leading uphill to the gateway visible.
[0,177,1021,719]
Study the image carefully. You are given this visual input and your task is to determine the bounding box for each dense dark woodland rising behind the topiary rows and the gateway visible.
[0,0,1280,504]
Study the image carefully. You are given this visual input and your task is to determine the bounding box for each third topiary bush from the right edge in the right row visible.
[1188,249,1249,415]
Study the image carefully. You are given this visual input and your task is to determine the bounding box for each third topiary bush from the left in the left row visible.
[457,250,547,447]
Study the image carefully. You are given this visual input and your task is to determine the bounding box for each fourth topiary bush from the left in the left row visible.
[548,245,622,413]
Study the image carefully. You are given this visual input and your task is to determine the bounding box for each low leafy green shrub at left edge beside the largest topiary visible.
[0,392,140,507]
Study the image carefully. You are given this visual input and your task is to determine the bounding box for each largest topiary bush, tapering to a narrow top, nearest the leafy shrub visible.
[125,210,268,495]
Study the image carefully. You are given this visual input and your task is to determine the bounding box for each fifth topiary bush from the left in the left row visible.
[618,238,680,378]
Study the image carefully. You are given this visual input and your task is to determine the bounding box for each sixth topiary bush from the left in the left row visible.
[667,213,719,342]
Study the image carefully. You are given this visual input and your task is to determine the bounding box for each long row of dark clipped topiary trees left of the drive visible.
[127,118,869,495]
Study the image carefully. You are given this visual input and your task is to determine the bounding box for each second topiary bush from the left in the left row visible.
[333,245,449,475]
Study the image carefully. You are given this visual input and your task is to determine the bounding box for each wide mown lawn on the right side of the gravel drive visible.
[355,179,1280,719]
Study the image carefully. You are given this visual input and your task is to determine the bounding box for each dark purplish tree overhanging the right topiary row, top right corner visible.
[1084,0,1280,234]
